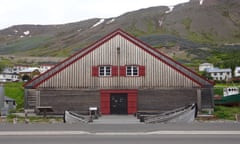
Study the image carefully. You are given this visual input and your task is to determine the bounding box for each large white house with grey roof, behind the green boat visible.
[206,68,232,80]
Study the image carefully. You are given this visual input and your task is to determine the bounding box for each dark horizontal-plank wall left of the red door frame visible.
[40,89,100,114]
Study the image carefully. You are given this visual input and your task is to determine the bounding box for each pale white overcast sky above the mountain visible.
[0,0,189,29]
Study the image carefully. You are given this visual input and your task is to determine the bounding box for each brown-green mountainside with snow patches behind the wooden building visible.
[0,0,240,64]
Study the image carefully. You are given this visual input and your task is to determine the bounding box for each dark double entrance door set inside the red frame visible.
[110,93,128,114]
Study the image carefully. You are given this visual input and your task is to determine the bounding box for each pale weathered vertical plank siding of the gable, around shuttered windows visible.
[39,35,199,89]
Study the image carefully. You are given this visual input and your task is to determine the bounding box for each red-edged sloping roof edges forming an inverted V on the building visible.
[24,29,213,88]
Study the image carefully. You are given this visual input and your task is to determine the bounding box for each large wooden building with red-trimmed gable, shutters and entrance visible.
[24,29,213,114]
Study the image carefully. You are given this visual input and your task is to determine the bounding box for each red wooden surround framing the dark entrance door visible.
[100,90,137,114]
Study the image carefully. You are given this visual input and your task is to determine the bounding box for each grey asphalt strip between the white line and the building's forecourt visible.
[0,122,240,133]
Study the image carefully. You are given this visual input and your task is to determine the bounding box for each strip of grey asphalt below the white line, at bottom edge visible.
[0,135,240,144]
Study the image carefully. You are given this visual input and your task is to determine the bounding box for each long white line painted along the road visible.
[0,131,240,136]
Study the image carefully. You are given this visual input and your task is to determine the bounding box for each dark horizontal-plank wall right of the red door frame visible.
[138,88,197,111]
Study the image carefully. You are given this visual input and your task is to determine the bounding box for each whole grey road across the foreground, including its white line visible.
[0,122,240,144]
